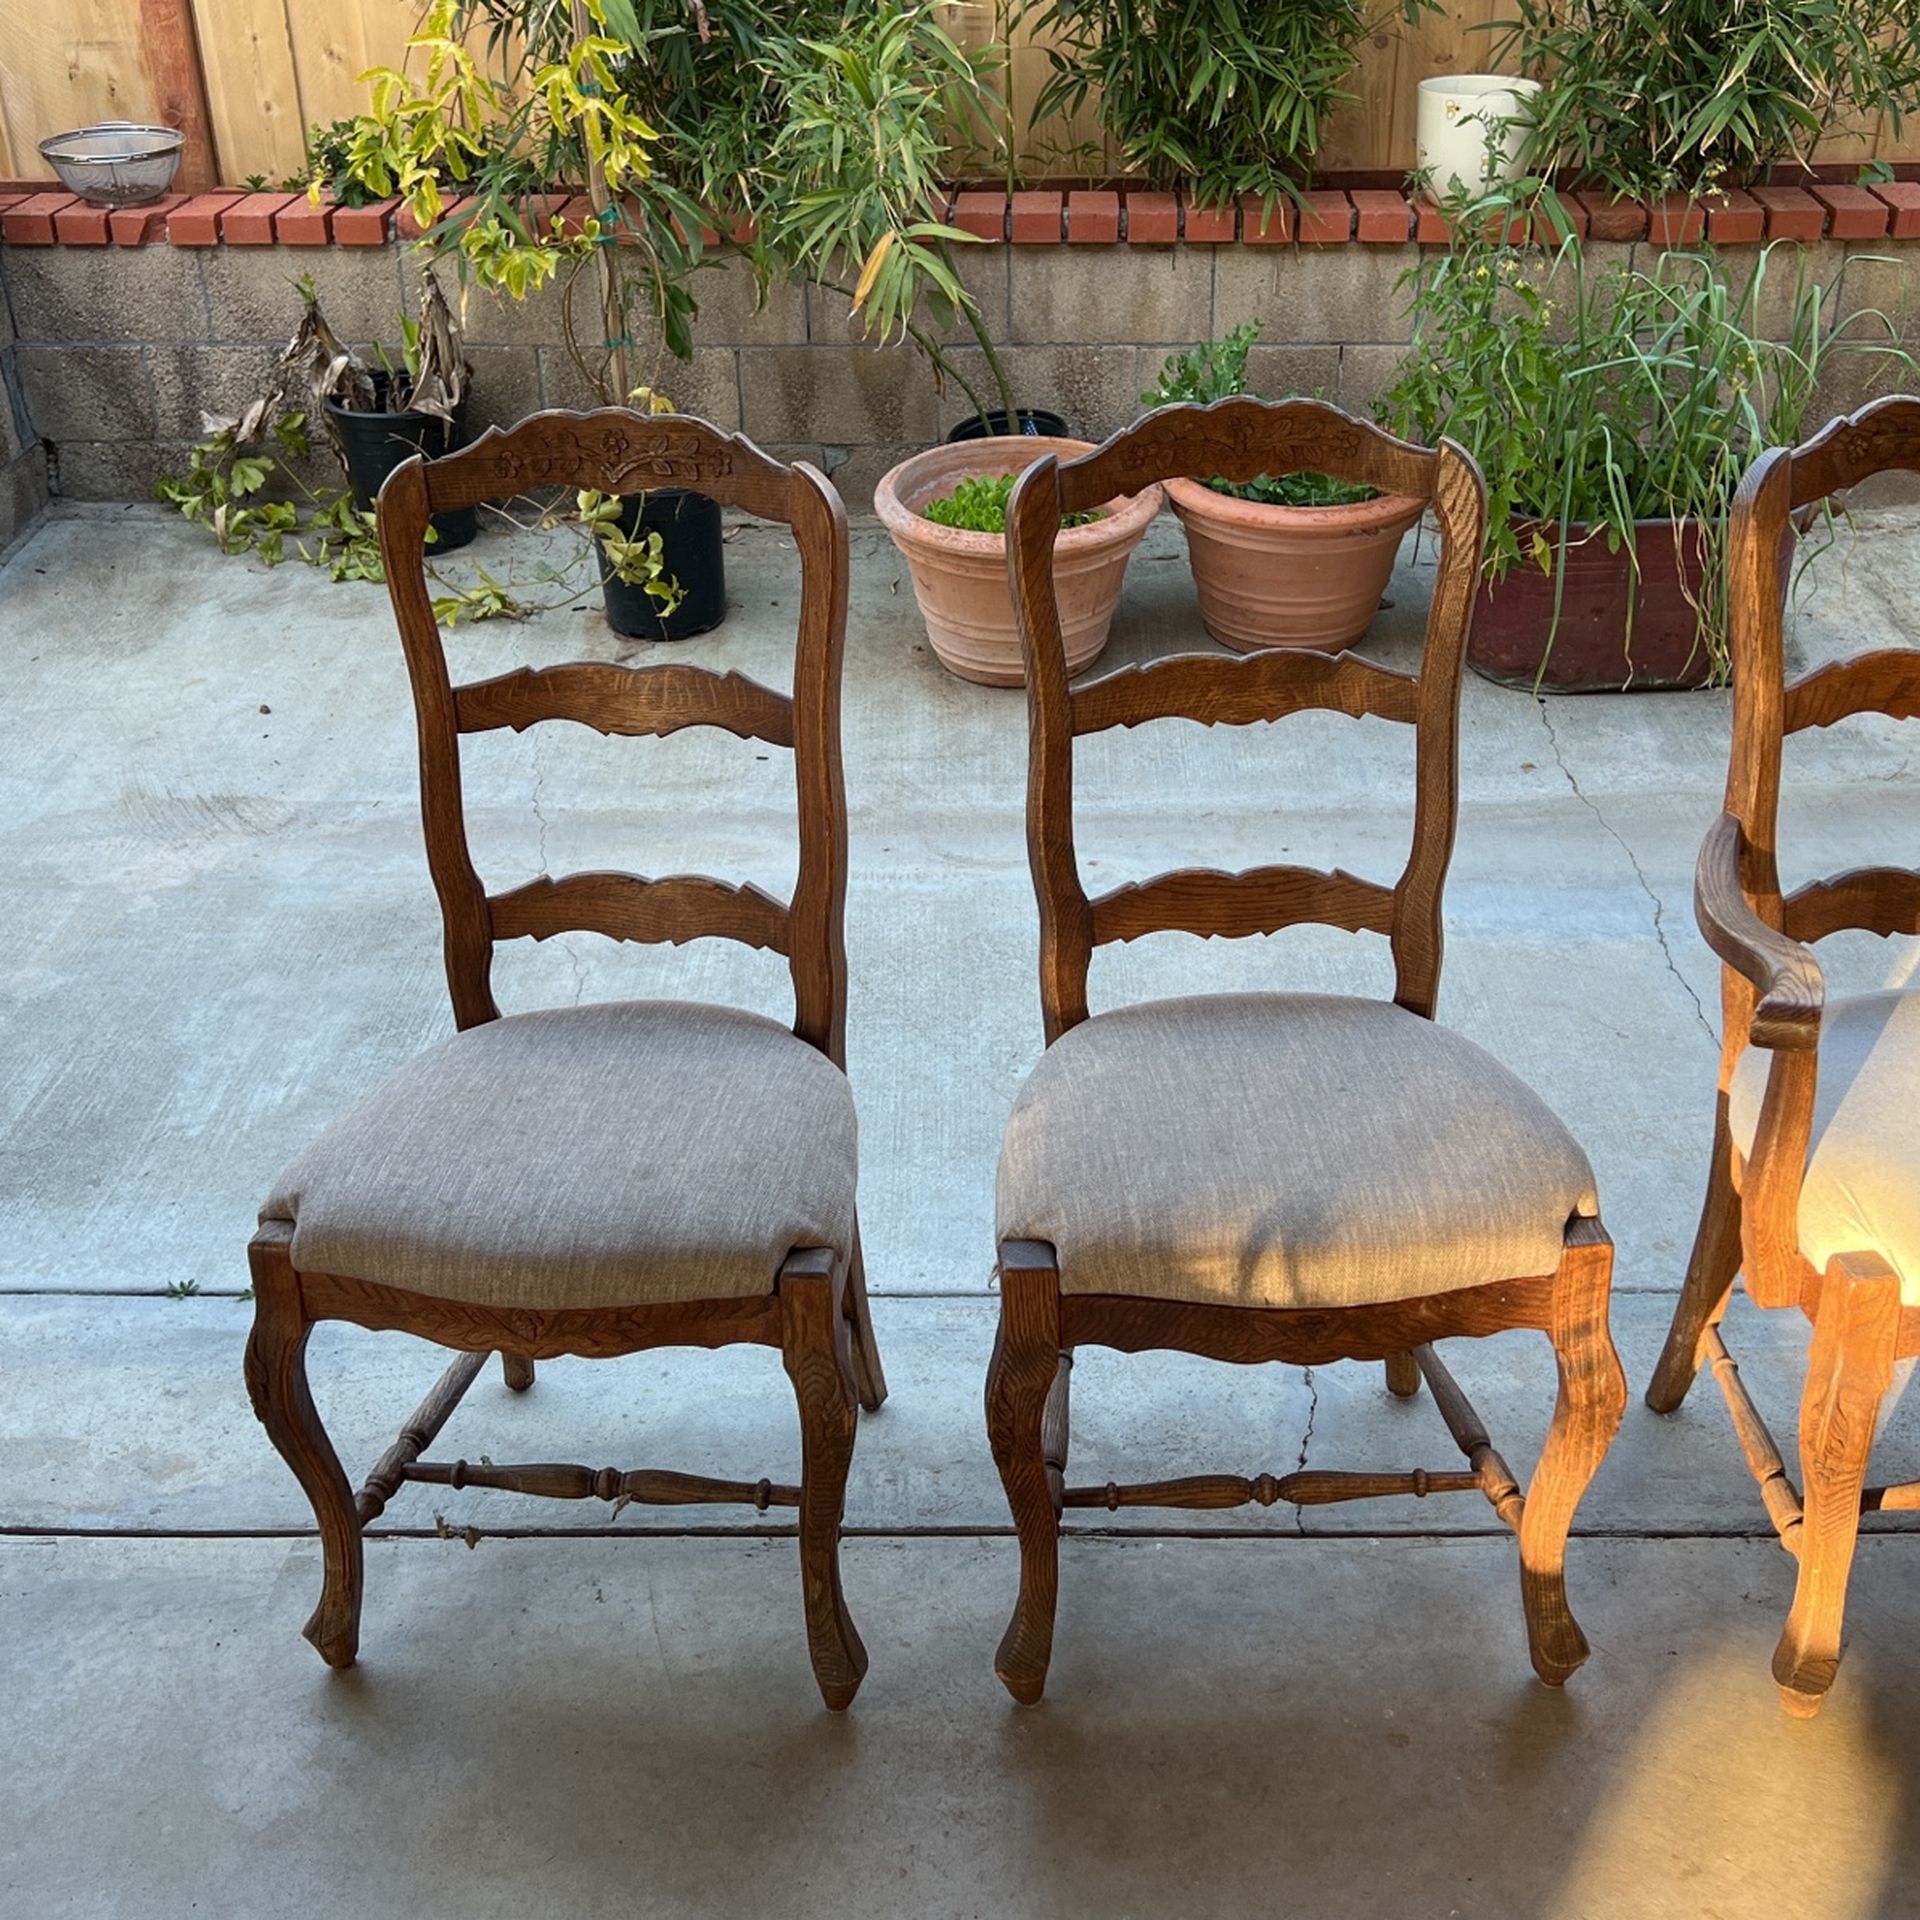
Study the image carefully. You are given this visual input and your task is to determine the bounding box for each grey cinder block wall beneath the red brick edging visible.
[0,224,1920,518]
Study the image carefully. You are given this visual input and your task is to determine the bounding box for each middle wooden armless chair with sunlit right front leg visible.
[987,399,1626,1703]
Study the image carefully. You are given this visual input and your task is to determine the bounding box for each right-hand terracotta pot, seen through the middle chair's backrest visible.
[1167,480,1425,653]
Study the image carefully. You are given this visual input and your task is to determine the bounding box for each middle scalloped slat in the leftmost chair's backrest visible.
[453,660,793,747]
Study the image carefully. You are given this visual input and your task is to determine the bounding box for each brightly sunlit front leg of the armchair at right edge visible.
[1774,1254,1901,1718]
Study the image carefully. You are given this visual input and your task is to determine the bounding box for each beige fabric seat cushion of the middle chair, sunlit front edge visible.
[998,995,1599,1308]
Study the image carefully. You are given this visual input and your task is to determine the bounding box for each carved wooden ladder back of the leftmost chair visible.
[378,407,847,1066]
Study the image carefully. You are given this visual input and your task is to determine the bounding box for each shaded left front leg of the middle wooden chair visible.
[987,1240,1066,1707]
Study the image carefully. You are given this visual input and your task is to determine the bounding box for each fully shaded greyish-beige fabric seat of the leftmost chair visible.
[261,1000,856,1308]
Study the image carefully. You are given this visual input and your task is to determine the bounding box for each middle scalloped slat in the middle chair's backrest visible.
[1071,649,1419,735]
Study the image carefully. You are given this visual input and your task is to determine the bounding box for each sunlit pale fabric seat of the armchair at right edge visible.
[1726,993,1920,1306]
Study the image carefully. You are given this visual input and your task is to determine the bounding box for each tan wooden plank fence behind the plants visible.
[0,0,1920,186]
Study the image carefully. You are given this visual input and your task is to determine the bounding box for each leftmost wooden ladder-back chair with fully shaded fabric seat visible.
[246,411,885,1709]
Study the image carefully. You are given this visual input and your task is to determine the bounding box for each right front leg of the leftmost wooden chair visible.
[780,1250,866,1713]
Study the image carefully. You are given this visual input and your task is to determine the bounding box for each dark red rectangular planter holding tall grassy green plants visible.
[1467,520,1793,693]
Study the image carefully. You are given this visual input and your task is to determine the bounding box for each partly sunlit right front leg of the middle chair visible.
[1521,1221,1626,1686]
